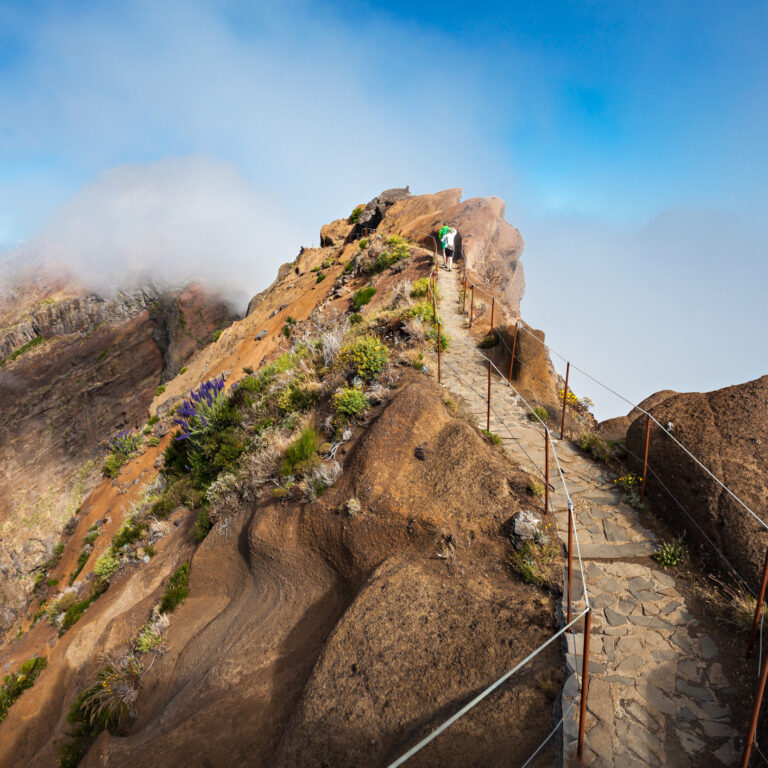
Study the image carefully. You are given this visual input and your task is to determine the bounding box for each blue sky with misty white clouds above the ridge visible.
[0,0,768,412]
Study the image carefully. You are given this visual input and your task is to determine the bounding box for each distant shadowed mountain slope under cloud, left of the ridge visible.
[0,272,232,631]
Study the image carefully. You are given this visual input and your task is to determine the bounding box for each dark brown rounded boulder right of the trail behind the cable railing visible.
[627,376,768,584]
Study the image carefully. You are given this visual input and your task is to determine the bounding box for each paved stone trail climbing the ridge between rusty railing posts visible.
[439,270,738,768]
